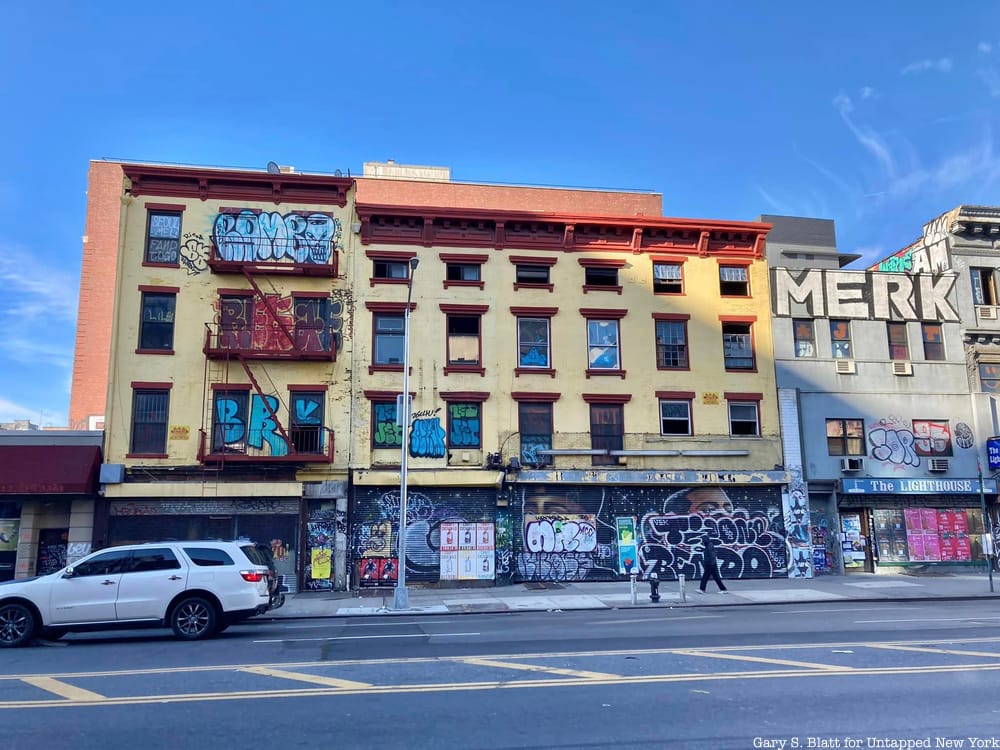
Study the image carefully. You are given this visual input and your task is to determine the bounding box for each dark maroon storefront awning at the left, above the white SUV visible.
[0,445,101,495]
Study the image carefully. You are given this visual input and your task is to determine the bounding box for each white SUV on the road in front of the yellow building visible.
[0,541,270,648]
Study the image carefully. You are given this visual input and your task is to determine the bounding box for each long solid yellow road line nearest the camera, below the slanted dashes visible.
[0,663,1000,709]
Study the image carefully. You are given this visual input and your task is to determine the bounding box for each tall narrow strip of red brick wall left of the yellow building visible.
[69,161,122,429]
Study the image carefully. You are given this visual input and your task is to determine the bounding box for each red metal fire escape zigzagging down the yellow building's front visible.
[199,234,338,465]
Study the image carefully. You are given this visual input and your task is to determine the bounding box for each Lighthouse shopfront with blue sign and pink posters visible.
[837,477,997,573]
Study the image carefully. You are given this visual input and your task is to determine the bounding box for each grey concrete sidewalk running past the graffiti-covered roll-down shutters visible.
[262,571,1000,618]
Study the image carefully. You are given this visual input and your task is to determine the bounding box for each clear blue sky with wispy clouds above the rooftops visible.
[0,0,1000,426]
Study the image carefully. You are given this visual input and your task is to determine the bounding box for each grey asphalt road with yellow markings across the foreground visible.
[0,601,1000,750]
